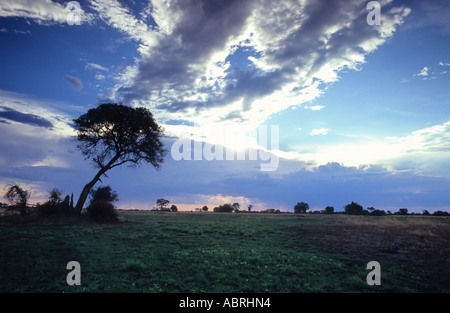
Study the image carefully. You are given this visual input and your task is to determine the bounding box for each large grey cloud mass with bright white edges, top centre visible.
[100,0,409,130]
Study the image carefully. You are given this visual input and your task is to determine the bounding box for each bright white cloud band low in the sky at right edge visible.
[284,121,450,177]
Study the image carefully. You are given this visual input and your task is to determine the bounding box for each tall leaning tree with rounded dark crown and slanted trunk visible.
[74,103,167,213]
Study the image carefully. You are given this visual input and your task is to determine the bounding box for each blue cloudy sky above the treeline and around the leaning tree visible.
[0,0,450,213]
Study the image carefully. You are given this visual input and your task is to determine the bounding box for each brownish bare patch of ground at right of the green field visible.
[295,216,450,290]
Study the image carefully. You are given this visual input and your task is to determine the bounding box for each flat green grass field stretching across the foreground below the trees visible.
[0,211,450,293]
